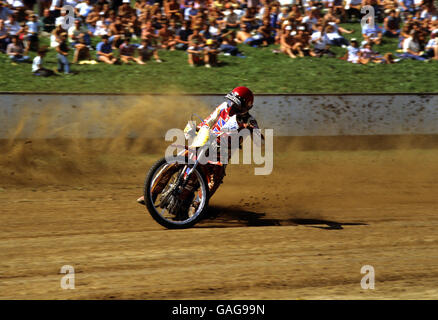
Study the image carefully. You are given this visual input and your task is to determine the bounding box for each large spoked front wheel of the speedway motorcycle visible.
[144,158,209,229]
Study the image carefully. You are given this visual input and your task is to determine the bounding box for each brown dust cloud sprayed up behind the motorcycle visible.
[0,96,211,185]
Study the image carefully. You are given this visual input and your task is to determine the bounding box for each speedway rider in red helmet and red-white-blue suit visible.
[137,86,263,204]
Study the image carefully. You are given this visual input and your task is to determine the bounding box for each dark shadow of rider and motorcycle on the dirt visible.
[197,206,368,230]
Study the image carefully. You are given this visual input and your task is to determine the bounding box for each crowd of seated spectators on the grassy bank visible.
[0,0,438,75]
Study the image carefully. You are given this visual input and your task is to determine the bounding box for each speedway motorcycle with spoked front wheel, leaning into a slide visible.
[143,116,238,229]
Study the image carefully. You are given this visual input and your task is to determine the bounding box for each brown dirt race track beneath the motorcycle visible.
[0,138,438,299]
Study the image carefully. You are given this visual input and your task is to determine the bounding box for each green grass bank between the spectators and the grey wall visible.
[0,24,438,93]
